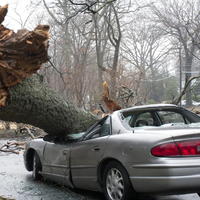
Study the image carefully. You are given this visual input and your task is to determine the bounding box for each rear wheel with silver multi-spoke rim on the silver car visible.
[103,161,137,200]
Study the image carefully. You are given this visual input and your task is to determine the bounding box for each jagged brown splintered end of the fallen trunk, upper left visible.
[0,5,49,107]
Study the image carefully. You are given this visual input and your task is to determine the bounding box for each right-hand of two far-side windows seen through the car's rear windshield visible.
[157,111,186,124]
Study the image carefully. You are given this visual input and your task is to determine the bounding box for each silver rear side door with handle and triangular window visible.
[71,117,111,190]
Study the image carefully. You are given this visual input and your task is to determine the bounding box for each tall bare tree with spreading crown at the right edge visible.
[151,0,200,105]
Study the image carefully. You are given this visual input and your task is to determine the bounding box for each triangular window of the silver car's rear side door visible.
[83,116,111,140]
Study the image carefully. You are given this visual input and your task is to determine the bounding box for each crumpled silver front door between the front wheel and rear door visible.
[42,142,71,185]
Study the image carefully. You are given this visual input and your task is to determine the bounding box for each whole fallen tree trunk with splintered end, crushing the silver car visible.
[0,5,96,135]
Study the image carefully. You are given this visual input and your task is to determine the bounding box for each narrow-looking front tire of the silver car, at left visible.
[32,152,42,181]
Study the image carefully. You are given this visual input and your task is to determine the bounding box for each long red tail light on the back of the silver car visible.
[151,140,200,157]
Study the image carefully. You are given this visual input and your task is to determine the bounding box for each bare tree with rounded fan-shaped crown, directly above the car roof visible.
[123,14,170,101]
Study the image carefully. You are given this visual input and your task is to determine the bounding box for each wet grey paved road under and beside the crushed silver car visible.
[0,142,200,200]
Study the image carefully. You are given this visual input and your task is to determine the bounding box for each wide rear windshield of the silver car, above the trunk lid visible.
[122,107,200,129]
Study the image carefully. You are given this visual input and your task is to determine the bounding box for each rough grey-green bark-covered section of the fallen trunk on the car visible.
[0,75,97,136]
